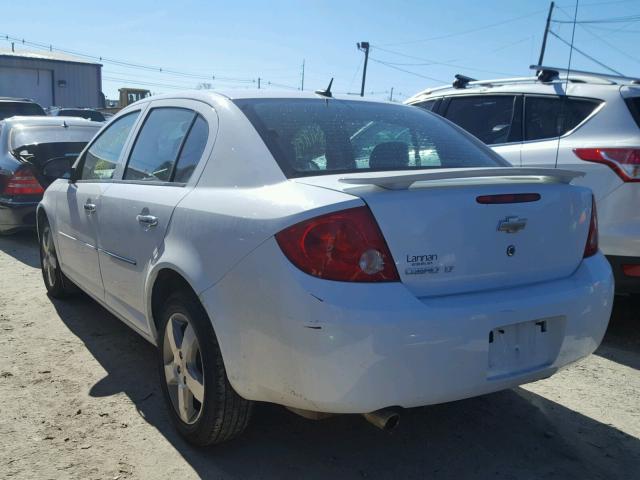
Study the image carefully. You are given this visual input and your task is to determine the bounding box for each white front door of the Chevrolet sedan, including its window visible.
[56,110,140,299]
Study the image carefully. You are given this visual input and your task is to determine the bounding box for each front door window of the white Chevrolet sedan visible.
[79,111,140,180]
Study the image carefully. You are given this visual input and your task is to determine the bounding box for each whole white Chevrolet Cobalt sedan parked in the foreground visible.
[37,91,613,445]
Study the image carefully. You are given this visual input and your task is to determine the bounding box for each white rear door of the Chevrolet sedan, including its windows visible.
[99,100,217,331]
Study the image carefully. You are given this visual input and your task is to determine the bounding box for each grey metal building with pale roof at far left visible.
[0,49,104,108]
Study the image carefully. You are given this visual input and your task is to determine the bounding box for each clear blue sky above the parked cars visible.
[0,0,640,101]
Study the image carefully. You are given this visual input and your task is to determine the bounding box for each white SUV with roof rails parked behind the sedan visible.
[406,66,640,294]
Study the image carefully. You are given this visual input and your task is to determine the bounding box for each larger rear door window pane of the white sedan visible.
[123,107,195,182]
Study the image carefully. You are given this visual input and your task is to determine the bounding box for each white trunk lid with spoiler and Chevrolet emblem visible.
[296,168,591,297]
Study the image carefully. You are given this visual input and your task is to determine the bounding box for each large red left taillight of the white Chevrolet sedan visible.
[276,207,399,282]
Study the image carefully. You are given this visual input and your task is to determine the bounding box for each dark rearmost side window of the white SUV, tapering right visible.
[524,96,600,140]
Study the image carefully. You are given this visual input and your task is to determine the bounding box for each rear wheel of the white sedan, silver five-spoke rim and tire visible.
[158,292,253,447]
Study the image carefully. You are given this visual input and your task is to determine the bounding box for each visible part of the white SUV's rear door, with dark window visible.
[440,94,522,167]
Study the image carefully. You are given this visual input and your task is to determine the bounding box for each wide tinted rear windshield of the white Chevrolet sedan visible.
[235,99,509,178]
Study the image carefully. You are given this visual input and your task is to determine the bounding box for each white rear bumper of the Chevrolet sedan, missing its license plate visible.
[201,241,614,413]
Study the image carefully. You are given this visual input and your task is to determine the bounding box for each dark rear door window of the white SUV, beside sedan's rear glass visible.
[445,95,515,145]
